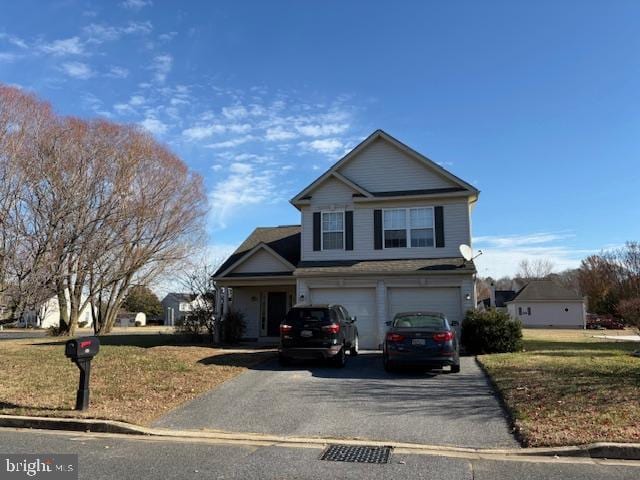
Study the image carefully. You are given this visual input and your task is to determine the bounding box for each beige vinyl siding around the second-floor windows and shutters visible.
[302,199,471,260]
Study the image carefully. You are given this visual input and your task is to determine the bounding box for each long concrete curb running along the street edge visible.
[0,415,640,460]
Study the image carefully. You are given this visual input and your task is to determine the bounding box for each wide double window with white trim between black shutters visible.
[382,207,434,248]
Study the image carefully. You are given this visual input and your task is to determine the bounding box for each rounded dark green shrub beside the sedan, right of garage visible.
[460,309,522,355]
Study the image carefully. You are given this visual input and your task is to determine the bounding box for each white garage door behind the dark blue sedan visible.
[389,287,462,324]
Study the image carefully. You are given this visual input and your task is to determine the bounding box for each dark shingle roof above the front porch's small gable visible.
[213,225,300,277]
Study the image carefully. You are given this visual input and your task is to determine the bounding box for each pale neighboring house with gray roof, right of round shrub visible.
[507,280,586,328]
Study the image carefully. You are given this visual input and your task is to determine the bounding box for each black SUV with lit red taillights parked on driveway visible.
[278,305,358,367]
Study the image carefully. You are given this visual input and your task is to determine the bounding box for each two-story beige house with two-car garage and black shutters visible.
[214,130,479,348]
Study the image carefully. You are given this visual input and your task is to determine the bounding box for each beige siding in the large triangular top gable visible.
[338,139,459,194]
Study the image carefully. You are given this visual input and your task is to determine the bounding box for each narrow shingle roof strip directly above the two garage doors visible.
[295,258,476,275]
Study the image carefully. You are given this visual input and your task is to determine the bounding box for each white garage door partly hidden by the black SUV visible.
[310,288,380,348]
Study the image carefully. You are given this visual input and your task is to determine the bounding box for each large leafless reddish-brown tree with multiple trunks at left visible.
[0,87,206,334]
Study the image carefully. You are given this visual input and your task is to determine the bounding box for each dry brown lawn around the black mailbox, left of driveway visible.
[0,337,273,425]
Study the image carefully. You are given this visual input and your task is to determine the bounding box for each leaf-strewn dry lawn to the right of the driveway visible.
[479,330,640,446]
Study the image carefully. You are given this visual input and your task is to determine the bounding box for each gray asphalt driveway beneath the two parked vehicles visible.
[154,353,518,447]
